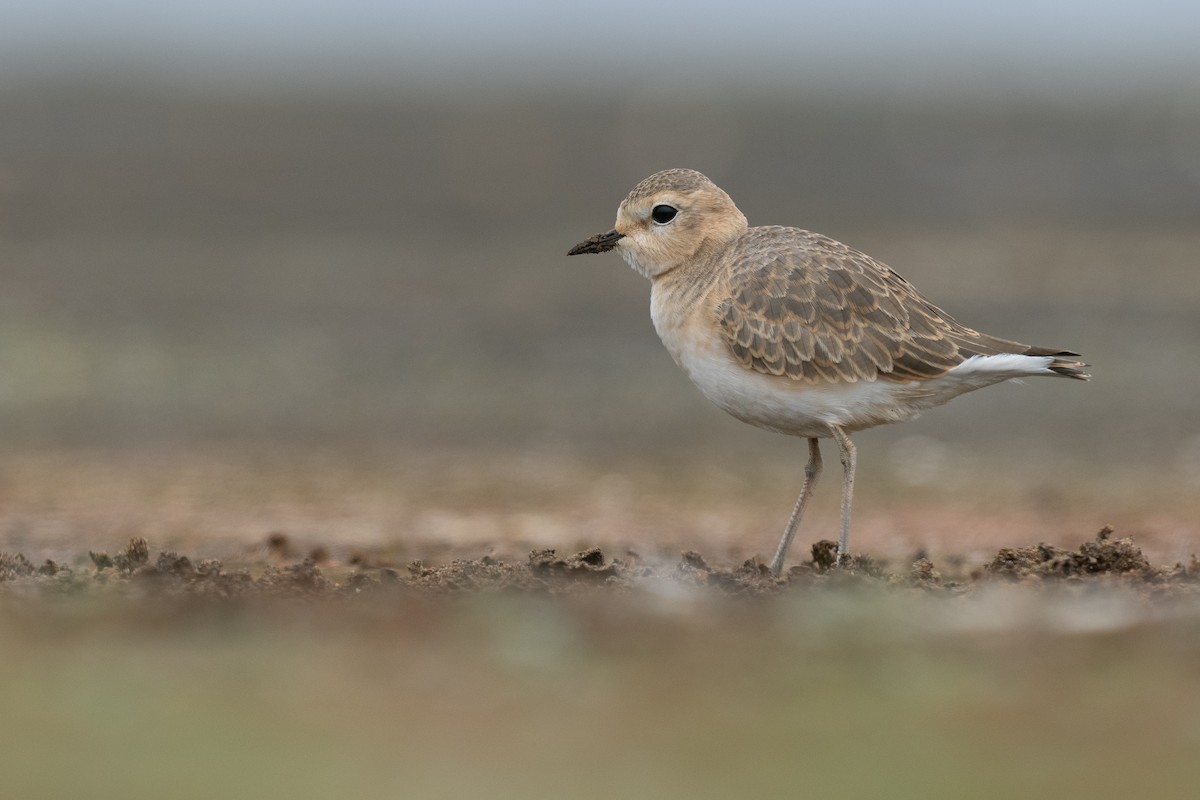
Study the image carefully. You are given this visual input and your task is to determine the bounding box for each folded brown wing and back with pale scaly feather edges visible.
[718,228,1056,383]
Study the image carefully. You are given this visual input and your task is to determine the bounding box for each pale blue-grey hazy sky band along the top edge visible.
[0,0,1200,92]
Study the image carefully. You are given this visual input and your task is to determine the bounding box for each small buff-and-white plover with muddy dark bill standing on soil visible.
[568,169,1091,576]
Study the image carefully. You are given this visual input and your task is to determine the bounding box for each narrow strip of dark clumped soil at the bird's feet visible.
[0,528,1200,599]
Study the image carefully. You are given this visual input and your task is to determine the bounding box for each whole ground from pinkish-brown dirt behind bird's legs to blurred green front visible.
[0,453,1200,800]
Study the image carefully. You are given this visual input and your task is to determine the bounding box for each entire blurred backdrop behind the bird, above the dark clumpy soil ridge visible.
[0,0,1200,557]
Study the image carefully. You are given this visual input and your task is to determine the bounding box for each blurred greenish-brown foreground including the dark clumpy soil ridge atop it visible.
[0,532,1200,799]
